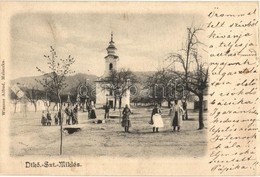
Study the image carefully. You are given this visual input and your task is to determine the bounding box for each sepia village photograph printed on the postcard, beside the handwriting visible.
[9,13,209,158]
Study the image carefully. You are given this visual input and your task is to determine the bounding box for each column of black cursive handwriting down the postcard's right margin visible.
[206,7,259,175]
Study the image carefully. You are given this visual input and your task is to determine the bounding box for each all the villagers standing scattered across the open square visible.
[41,100,187,132]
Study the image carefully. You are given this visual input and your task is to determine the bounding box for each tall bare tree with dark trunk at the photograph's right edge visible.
[166,26,208,129]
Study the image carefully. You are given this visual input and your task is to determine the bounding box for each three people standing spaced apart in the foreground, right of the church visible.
[122,100,187,133]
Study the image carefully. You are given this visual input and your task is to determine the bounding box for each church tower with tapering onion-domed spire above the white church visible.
[104,32,119,77]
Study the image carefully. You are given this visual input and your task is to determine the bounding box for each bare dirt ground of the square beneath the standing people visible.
[10,108,207,158]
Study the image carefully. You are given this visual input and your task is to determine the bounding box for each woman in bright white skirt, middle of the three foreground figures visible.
[151,104,164,132]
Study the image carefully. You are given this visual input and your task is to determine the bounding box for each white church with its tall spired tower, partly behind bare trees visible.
[96,33,130,108]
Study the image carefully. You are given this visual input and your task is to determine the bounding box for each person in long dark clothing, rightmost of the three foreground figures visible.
[171,100,183,131]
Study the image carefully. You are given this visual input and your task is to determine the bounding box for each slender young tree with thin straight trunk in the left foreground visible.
[36,46,75,155]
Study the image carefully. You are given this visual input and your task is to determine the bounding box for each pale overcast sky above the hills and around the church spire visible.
[11,14,204,79]
